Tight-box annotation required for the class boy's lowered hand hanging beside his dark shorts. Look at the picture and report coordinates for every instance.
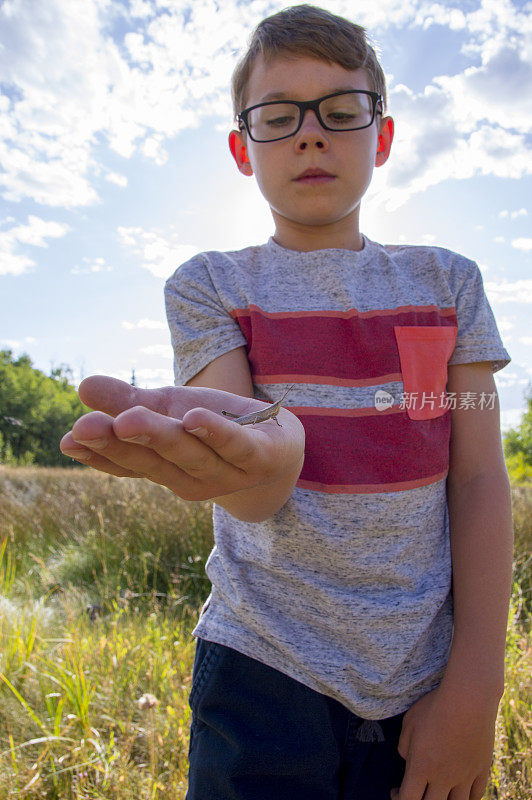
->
[391,683,498,800]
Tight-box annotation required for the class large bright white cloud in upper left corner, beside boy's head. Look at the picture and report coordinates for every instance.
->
[0,0,260,208]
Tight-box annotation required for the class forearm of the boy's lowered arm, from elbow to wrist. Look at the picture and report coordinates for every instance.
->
[444,472,513,695]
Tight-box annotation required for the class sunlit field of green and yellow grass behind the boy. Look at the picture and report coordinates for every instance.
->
[0,467,532,800]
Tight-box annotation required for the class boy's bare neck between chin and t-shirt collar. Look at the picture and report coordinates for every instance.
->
[271,207,364,252]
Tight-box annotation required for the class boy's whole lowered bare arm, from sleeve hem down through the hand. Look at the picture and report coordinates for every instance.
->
[392,362,513,800]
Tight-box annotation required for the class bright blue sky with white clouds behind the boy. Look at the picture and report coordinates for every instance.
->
[0,0,532,430]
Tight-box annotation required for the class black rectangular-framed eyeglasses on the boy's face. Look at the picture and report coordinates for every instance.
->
[236,89,382,142]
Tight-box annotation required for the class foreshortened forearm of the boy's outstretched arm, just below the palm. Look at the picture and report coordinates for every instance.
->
[213,455,305,522]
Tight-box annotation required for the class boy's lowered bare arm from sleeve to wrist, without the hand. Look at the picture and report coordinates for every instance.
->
[444,362,513,700]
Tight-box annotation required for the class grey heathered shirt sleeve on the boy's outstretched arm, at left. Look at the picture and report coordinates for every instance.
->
[164,253,246,386]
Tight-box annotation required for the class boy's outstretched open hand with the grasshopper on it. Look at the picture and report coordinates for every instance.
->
[59,375,305,500]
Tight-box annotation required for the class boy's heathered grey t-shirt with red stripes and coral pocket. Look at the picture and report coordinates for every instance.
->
[165,231,510,719]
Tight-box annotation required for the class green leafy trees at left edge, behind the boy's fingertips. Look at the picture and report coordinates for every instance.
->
[0,350,88,466]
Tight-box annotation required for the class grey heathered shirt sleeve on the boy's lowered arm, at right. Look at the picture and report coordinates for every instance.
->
[449,260,511,372]
